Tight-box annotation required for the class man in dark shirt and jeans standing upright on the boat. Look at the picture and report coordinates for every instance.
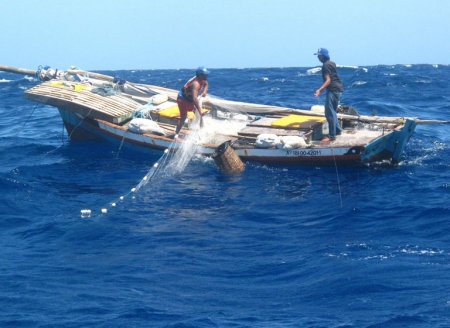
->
[314,48,344,142]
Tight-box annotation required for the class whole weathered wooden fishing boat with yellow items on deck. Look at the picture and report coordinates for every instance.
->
[0,67,432,165]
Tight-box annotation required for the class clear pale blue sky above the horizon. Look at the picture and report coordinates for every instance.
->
[0,0,450,70]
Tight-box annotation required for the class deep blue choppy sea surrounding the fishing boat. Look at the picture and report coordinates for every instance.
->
[0,65,450,328]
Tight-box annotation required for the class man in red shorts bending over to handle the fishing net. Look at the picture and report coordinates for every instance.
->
[175,67,209,134]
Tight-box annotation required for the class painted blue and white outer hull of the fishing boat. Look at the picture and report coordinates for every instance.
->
[59,108,415,165]
